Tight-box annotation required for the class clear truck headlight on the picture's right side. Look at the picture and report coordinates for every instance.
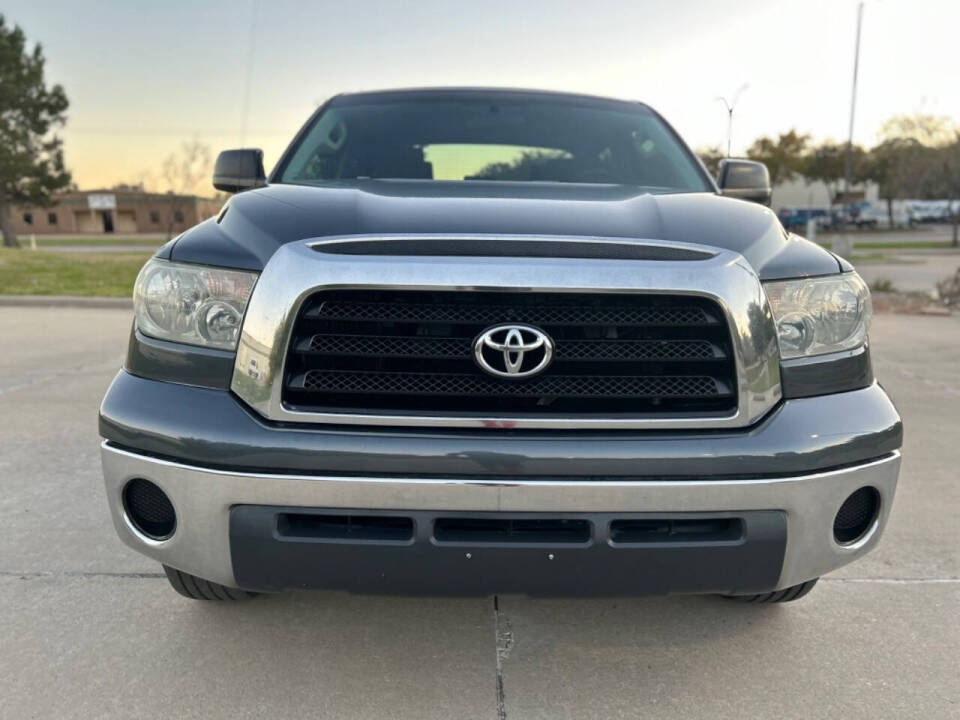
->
[764,273,873,359]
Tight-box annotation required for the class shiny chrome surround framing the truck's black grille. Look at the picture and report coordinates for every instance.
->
[231,234,781,429]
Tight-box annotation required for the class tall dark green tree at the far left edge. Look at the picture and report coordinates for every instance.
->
[0,15,70,247]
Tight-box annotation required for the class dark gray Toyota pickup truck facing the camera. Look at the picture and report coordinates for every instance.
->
[100,89,902,602]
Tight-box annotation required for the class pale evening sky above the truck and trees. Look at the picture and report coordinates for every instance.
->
[0,0,960,192]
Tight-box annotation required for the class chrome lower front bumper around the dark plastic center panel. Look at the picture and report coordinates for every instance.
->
[101,442,900,589]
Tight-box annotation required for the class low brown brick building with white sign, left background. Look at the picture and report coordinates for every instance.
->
[13,188,223,237]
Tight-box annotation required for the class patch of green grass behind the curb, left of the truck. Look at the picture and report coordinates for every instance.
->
[0,249,150,297]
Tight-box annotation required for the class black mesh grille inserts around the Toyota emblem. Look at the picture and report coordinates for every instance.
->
[283,290,737,419]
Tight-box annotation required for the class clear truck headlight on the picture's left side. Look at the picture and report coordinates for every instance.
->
[133,259,257,350]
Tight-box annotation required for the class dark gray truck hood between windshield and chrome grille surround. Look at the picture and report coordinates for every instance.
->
[167,180,841,280]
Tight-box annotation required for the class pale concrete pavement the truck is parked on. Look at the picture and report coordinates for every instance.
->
[0,307,960,720]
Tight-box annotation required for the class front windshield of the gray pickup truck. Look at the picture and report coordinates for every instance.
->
[279,98,711,192]
